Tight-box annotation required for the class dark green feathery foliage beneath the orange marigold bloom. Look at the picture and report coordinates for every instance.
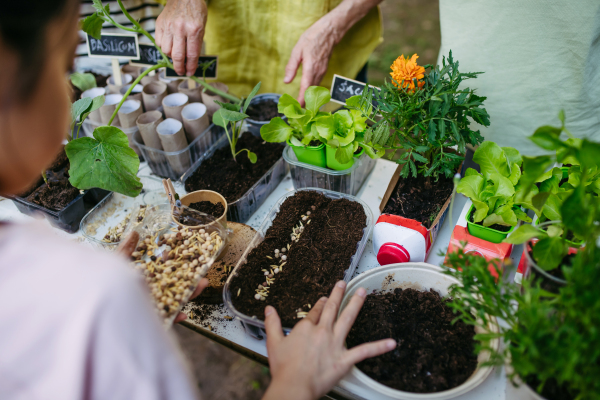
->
[349,52,490,180]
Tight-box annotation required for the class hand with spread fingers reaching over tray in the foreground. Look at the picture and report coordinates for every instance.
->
[263,281,396,400]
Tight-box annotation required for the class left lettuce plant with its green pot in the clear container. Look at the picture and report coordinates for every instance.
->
[260,86,331,167]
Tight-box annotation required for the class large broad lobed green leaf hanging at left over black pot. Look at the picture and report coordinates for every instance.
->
[65,126,142,197]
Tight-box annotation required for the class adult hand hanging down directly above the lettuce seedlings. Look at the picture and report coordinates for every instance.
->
[283,14,340,106]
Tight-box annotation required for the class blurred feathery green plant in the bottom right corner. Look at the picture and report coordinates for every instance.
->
[445,247,600,400]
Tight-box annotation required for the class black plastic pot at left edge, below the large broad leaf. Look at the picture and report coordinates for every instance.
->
[11,189,110,233]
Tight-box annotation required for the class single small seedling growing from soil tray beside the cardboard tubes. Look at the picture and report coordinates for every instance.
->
[213,82,260,164]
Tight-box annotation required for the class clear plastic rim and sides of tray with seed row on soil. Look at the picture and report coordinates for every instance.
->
[223,188,373,339]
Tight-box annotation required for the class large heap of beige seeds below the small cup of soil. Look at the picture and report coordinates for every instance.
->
[131,226,223,324]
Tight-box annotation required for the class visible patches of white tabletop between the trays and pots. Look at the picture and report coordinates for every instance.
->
[0,160,528,400]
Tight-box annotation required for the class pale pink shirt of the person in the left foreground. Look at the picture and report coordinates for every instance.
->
[0,222,198,400]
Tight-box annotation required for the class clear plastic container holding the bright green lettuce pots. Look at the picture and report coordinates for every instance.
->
[283,146,376,195]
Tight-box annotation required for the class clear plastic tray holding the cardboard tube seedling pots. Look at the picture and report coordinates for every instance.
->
[133,124,227,181]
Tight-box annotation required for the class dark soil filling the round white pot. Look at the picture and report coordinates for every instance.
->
[346,289,477,393]
